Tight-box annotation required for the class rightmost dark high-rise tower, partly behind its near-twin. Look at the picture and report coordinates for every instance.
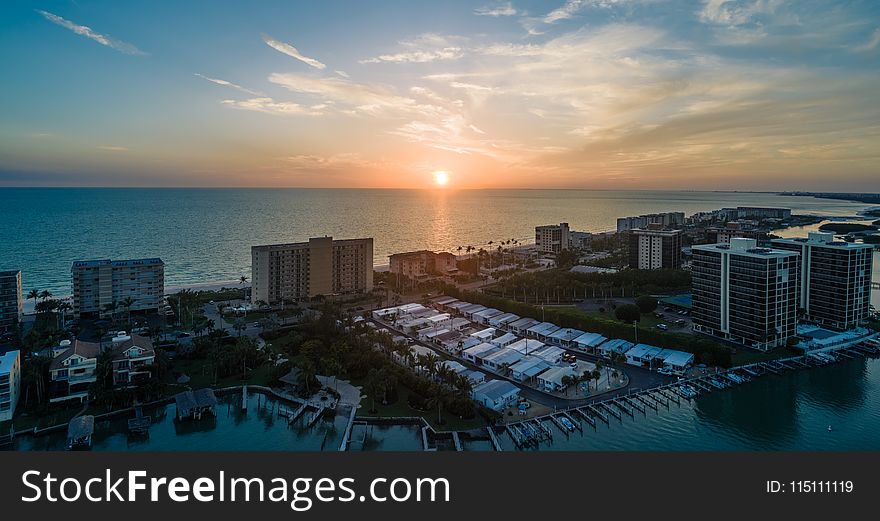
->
[771,232,874,330]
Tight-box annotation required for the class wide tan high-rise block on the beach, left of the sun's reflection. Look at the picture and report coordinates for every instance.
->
[251,237,373,304]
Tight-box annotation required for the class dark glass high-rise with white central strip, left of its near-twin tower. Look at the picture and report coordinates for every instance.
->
[692,238,800,351]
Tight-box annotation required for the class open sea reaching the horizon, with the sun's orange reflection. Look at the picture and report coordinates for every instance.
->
[0,188,865,295]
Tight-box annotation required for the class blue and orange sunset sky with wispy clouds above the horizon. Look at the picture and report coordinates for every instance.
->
[0,0,880,191]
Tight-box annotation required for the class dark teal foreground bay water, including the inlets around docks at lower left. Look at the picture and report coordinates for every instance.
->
[15,358,880,451]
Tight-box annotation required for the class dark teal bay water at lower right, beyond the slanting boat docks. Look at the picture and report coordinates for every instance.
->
[501,359,880,451]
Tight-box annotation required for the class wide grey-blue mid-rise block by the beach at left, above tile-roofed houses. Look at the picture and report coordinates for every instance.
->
[71,259,165,319]
